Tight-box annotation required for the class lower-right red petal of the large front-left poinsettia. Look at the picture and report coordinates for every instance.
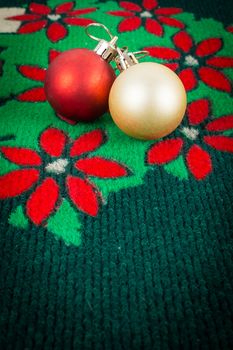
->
[66,176,99,216]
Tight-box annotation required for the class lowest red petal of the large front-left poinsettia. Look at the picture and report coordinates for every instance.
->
[26,178,59,225]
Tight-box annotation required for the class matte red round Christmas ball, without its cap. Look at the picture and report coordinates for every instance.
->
[45,49,116,121]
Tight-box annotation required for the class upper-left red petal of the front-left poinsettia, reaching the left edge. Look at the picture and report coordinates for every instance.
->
[0,146,42,166]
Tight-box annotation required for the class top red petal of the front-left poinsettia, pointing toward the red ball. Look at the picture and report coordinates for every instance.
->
[40,128,67,157]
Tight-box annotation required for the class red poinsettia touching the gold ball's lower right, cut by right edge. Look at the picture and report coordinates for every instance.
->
[147,98,233,180]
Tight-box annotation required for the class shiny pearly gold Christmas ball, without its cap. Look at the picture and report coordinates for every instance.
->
[109,62,187,140]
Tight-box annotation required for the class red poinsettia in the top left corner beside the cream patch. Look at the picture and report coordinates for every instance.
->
[7,1,96,42]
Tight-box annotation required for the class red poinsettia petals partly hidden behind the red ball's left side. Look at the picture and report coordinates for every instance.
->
[16,50,60,102]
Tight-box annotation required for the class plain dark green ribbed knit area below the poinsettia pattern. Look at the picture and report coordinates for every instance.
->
[0,154,233,350]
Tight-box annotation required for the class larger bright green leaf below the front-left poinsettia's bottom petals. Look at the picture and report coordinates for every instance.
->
[47,199,81,246]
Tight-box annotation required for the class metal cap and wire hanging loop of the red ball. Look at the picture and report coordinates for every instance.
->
[85,23,118,62]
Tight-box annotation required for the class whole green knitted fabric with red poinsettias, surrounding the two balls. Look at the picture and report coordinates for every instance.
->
[0,0,233,350]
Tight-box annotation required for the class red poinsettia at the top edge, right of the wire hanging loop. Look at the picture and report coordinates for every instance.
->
[108,0,184,36]
